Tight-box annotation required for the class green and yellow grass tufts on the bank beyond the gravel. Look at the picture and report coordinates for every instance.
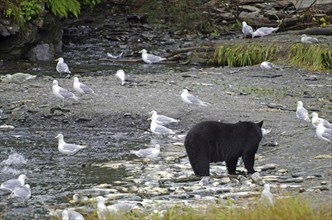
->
[204,41,332,71]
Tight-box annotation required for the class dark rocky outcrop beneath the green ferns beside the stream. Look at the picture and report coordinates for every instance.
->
[0,12,63,61]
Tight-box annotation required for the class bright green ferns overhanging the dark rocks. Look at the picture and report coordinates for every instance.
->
[0,0,102,26]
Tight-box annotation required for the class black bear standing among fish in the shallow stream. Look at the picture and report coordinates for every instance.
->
[184,121,263,176]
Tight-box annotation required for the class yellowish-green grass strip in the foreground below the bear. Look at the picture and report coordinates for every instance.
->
[79,198,332,220]
